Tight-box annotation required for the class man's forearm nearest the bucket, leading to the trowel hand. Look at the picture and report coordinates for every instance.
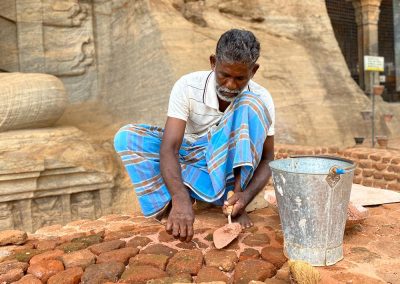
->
[239,160,271,204]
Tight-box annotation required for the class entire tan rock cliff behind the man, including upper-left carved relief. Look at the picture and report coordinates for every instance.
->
[0,0,400,145]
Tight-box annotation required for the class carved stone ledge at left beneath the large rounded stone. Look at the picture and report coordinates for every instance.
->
[0,127,118,233]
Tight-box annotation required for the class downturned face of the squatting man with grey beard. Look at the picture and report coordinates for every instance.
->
[210,55,259,102]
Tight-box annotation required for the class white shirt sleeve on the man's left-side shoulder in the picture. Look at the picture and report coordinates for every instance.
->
[167,78,189,121]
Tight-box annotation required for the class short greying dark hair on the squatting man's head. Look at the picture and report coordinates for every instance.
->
[215,29,260,65]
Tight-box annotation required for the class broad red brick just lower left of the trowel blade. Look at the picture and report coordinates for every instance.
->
[167,250,203,275]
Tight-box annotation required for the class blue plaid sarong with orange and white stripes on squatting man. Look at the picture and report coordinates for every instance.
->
[114,92,271,217]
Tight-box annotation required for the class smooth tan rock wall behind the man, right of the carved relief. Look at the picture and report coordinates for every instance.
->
[75,0,400,146]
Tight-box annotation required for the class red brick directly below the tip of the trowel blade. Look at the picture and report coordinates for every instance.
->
[204,249,238,272]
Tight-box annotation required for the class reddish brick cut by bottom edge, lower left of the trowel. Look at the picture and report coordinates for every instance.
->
[121,265,168,284]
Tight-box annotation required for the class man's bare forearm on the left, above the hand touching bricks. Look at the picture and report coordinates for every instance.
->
[160,151,190,200]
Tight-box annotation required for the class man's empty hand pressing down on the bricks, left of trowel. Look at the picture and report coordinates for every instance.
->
[165,197,194,242]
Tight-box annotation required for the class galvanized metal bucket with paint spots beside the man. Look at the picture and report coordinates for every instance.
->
[269,156,355,266]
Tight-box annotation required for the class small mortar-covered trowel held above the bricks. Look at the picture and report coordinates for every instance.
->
[213,191,242,249]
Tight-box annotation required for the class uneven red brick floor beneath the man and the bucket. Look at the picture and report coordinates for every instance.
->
[0,203,400,283]
